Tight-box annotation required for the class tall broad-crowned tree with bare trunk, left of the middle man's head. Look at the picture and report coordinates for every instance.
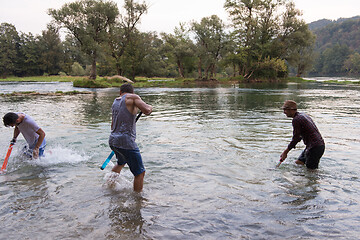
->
[48,0,119,79]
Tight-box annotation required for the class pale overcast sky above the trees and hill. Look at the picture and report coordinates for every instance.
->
[0,0,360,35]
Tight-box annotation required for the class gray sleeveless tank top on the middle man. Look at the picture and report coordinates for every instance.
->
[109,94,138,149]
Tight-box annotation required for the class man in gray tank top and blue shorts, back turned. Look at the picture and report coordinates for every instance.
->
[109,83,152,192]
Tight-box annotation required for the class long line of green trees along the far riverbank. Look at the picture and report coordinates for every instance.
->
[0,0,315,80]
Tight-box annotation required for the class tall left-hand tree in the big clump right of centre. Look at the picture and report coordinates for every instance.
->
[224,0,282,78]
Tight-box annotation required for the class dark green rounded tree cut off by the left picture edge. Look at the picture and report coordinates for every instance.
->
[0,23,19,77]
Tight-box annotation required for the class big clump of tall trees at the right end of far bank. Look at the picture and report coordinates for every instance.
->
[224,0,313,78]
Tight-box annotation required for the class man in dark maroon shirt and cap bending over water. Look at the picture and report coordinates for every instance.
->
[280,100,325,169]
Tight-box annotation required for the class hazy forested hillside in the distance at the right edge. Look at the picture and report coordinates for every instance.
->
[309,16,360,76]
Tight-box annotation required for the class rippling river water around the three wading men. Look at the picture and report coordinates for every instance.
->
[0,82,360,239]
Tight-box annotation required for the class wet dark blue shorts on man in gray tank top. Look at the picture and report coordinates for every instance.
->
[110,146,145,176]
